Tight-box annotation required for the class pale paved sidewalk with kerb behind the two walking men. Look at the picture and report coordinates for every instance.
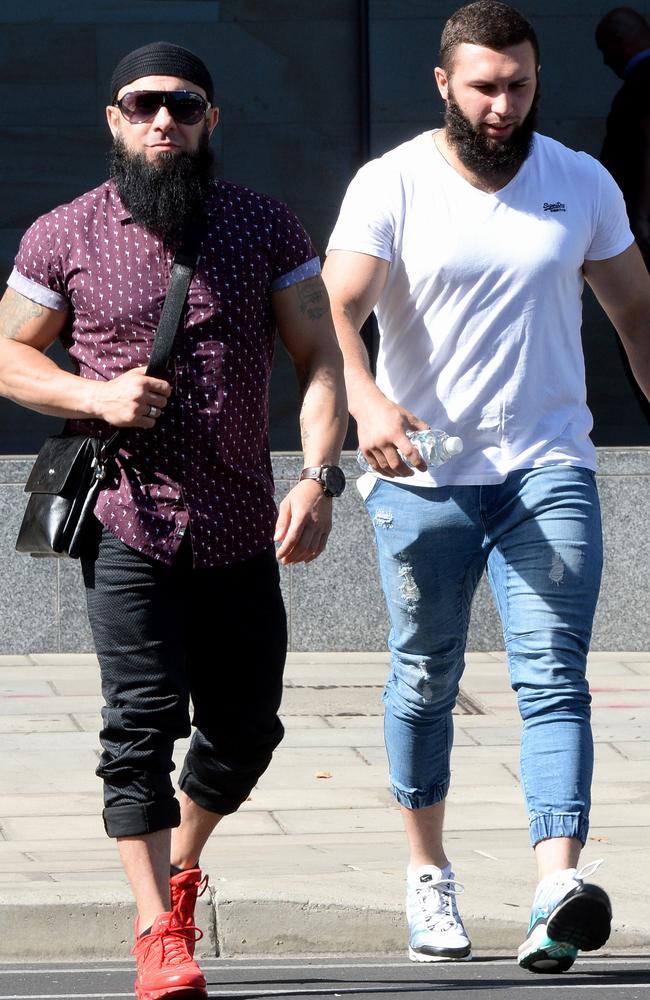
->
[0,652,650,960]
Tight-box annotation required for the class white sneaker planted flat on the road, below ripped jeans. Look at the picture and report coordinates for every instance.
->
[406,865,472,962]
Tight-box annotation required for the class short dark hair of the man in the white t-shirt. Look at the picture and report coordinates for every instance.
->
[440,0,539,73]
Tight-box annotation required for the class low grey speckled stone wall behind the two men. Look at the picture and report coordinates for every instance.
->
[0,448,650,653]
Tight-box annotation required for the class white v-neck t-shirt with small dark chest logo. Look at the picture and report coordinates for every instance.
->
[328,131,633,486]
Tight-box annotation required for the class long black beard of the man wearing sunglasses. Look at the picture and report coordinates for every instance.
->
[111,129,214,246]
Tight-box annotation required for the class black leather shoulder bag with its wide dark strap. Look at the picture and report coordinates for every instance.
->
[16,250,197,559]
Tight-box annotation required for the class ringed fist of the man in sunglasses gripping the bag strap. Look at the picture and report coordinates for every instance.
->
[88,367,172,430]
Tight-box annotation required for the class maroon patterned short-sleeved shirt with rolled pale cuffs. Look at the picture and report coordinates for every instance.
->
[8,181,320,566]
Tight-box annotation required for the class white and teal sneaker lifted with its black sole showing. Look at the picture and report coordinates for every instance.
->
[517,861,612,974]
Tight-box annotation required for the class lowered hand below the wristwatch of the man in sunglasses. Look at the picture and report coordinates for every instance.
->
[273,479,332,566]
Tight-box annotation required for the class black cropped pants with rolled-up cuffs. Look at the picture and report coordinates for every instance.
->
[82,530,287,837]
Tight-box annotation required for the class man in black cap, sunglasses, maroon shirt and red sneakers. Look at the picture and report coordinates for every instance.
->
[0,42,347,1000]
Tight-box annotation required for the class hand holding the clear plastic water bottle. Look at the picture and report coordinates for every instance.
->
[357,390,429,479]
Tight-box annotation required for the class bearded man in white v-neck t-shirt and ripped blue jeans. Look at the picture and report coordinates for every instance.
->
[324,0,650,972]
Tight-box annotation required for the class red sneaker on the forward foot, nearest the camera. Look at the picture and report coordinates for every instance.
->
[131,913,208,1000]
